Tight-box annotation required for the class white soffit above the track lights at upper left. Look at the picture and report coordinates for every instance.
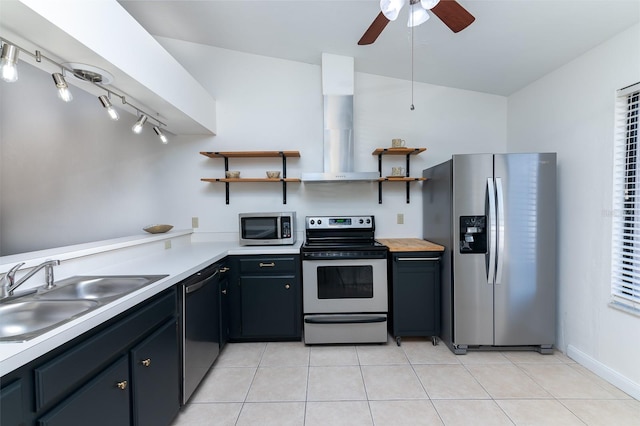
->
[0,0,216,135]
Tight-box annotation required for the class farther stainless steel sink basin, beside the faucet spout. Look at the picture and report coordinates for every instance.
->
[38,275,166,301]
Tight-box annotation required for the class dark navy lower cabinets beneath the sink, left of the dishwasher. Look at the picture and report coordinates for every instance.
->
[0,288,180,426]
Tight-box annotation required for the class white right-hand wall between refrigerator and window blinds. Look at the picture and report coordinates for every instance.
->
[508,25,640,398]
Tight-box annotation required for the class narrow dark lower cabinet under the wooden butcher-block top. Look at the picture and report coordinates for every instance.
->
[388,252,442,346]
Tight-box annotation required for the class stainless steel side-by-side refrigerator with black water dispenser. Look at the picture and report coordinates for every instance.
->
[422,153,557,354]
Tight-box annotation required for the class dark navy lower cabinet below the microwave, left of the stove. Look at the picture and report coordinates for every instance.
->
[229,255,302,341]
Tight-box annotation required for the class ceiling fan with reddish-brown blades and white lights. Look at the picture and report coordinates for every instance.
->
[358,0,476,45]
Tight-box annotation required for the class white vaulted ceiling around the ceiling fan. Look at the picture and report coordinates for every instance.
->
[119,0,640,95]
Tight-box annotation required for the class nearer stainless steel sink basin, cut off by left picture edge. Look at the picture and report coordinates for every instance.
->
[0,300,99,342]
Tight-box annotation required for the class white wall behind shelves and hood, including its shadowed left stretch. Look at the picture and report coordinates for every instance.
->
[0,39,507,254]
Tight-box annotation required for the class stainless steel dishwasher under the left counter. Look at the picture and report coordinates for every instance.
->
[179,263,228,404]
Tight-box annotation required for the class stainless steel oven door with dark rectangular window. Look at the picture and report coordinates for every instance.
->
[302,259,387,314]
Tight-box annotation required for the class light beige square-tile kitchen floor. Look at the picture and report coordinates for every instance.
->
[173,338,640,426]
